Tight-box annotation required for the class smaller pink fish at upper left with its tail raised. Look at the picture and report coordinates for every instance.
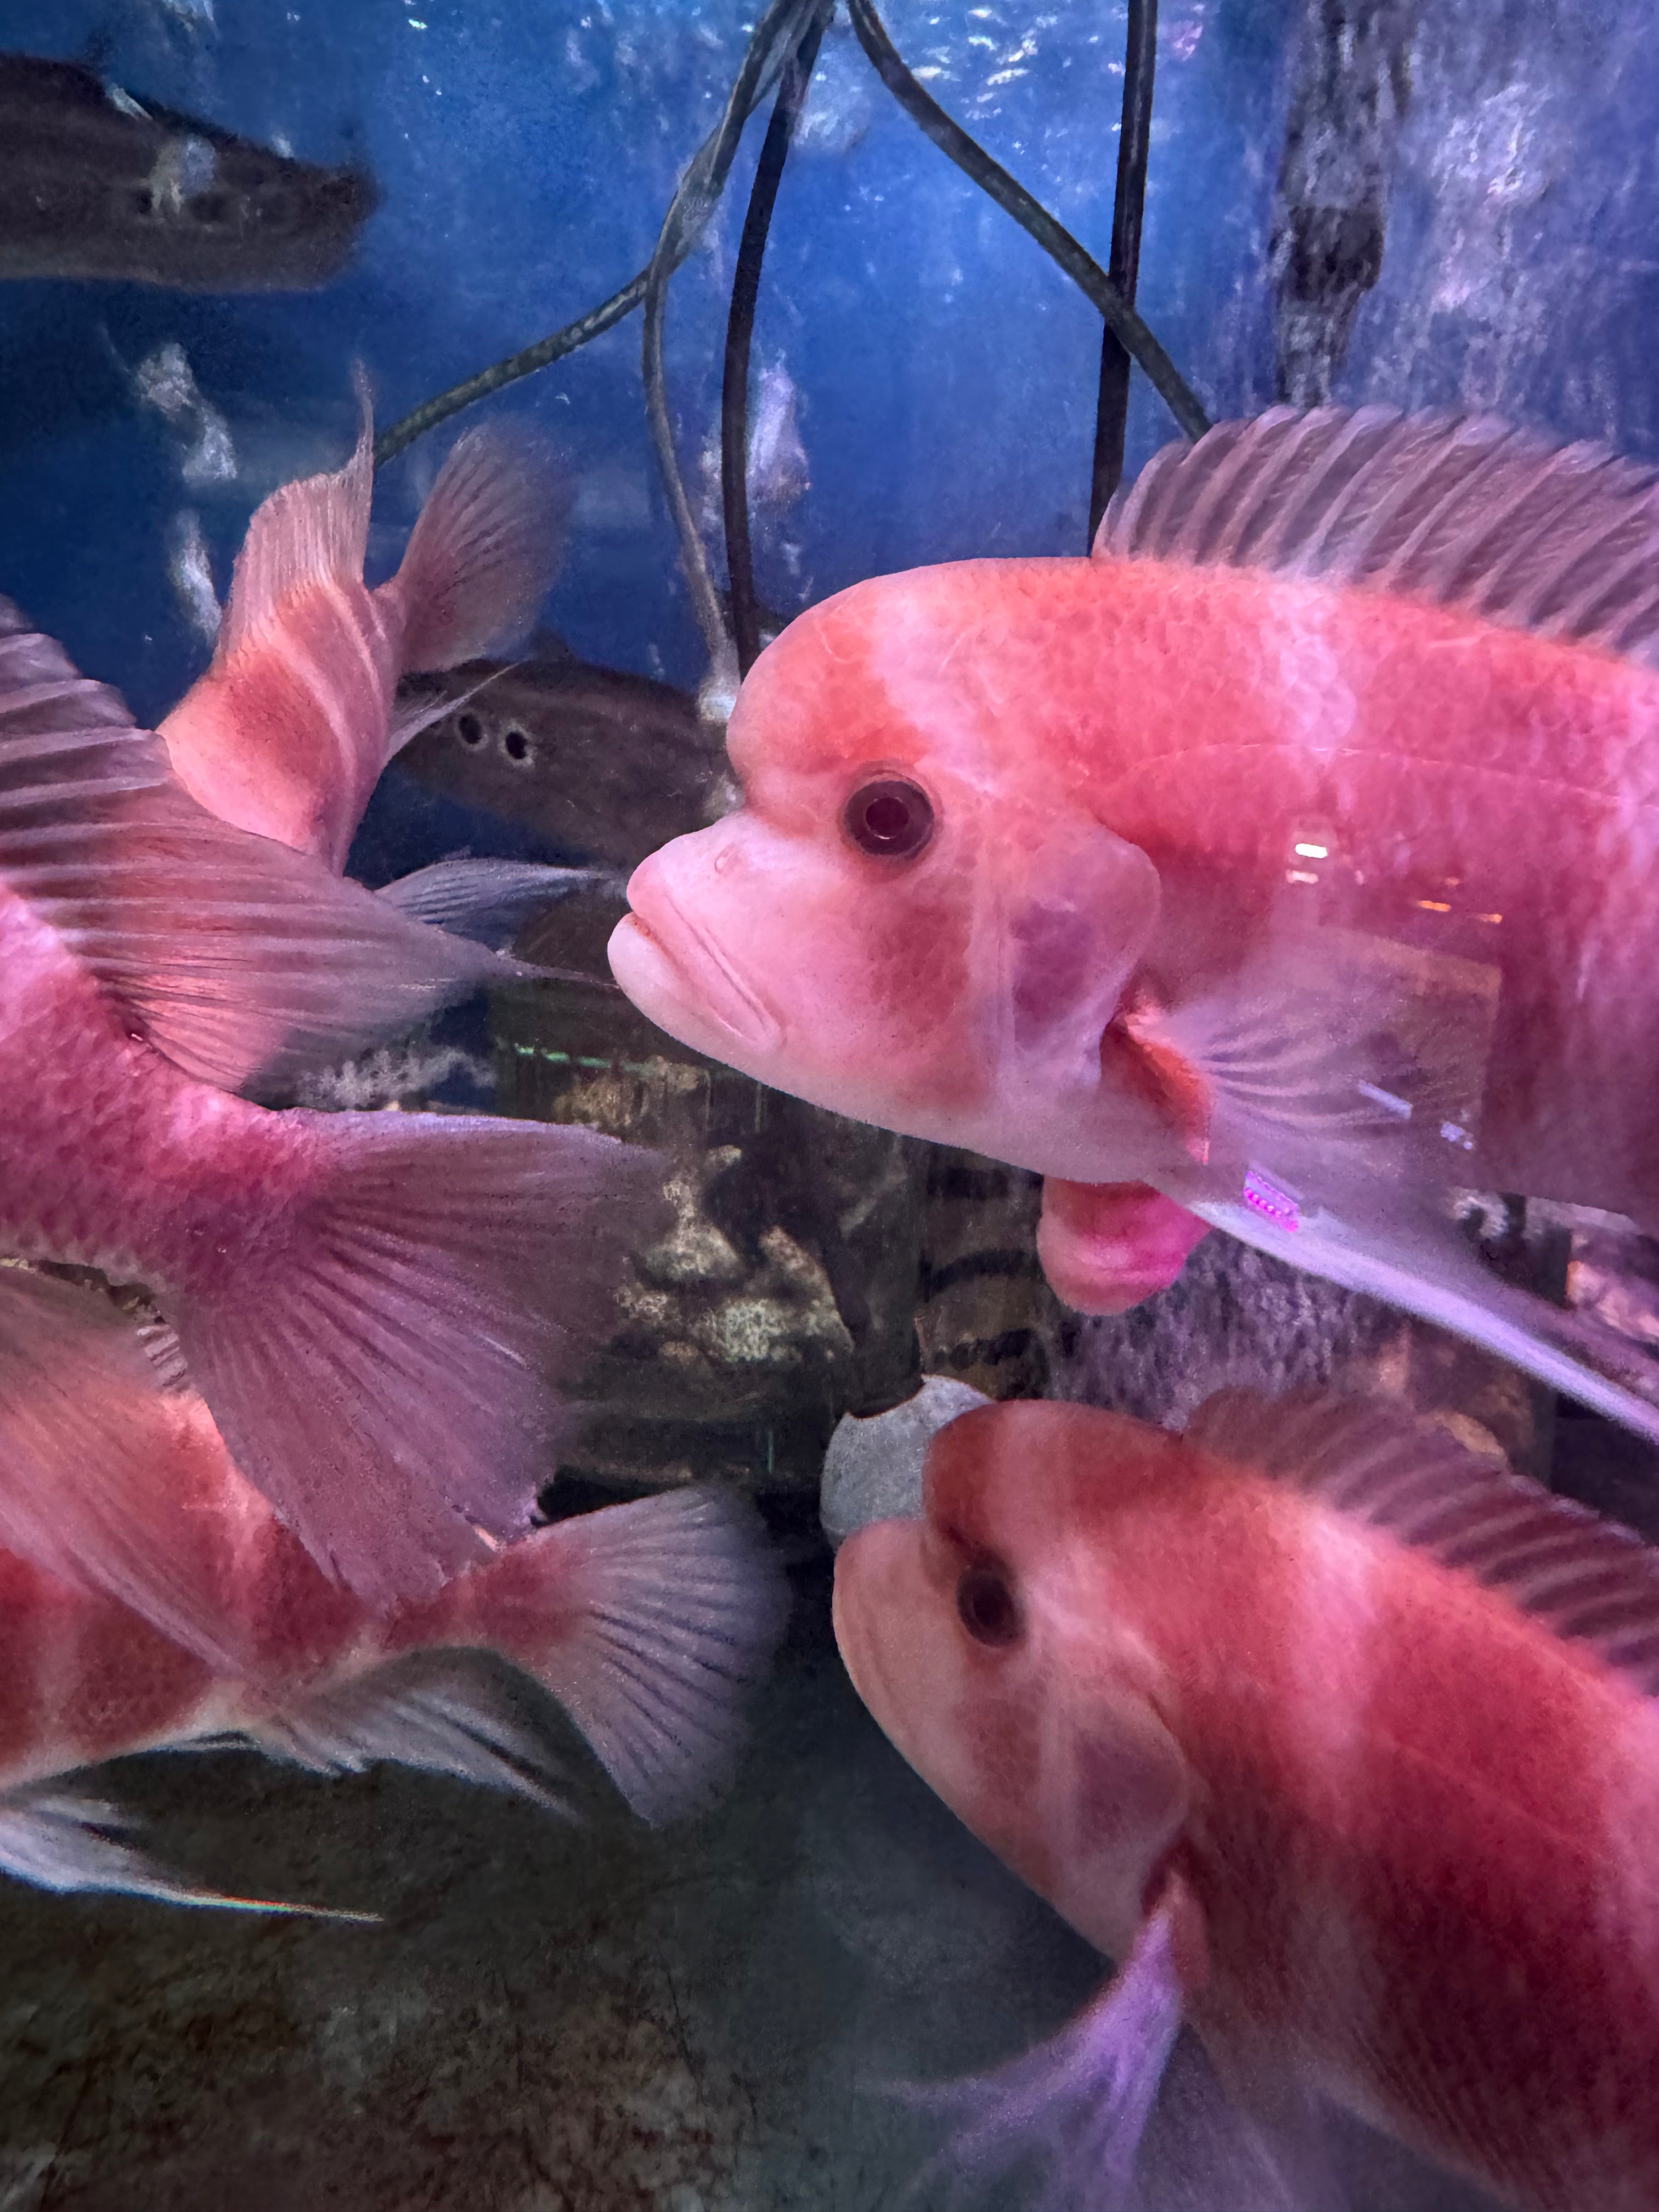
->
[161,403,568,874]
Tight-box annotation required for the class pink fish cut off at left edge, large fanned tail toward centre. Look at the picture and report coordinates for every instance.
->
[0,602,659,1657]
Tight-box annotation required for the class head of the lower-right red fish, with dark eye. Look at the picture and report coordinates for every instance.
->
[834,1400,1188,1955]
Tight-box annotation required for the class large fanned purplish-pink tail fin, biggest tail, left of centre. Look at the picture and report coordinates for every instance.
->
[168,1113,662,1606]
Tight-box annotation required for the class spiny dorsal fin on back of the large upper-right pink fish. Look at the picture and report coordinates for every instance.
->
[1095,407,1659,668]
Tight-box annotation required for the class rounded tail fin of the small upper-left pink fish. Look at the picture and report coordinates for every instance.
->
[387,425,571,676]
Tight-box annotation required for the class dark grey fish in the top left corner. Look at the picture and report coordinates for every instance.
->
[0,53,378,292]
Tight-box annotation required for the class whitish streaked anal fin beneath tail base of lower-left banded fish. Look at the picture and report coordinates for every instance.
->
[240,1650,579,1818]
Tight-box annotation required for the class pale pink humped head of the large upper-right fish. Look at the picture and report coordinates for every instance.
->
[611,579,1161,1179]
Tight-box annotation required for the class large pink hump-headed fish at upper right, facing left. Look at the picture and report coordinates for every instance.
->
[611,409,1659,1434]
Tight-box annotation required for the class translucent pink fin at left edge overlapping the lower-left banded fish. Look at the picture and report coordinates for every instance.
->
[0,1267,246,1674]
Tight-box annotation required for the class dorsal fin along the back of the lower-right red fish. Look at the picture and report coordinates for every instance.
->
[1186,1389,1659,1695]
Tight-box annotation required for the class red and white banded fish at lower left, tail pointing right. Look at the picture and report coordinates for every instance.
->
[0,1269,783,1903]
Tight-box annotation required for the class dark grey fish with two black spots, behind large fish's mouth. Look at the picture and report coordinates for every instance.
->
[396,633,725,867]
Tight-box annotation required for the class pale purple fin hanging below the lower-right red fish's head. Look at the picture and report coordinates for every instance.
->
[896,1882,1197,2212]
